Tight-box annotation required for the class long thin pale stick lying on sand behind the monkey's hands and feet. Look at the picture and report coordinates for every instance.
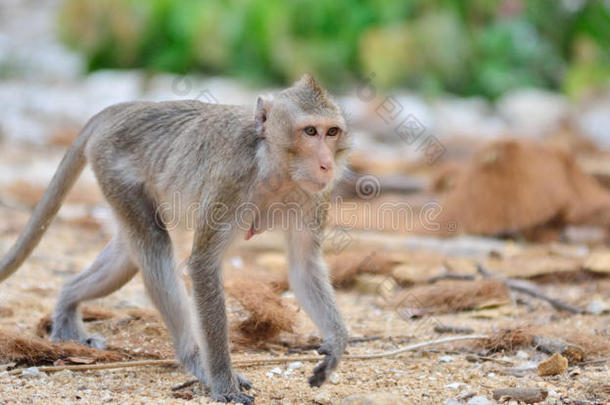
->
[3,335,489,375]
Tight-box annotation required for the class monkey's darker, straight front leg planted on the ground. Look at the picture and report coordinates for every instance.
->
[189,229,254,404]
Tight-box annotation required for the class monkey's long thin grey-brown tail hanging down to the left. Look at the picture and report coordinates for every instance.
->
[0,119,95,282]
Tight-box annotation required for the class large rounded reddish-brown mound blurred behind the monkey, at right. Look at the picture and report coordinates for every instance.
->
[430,140,610,235]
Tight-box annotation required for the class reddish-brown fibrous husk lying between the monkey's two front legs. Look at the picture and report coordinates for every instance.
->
[226,277,295,344]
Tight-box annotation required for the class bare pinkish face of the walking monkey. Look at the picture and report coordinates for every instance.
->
[289,116,346,192]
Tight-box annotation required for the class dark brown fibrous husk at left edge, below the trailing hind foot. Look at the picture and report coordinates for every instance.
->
[0,331,125,366]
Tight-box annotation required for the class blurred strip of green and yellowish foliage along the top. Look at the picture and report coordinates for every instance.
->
[59,0,610,98]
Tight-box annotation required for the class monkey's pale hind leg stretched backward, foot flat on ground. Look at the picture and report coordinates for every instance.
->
[51,235,138,349]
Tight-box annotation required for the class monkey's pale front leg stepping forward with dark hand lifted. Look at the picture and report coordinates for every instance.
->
[288,228,348,387]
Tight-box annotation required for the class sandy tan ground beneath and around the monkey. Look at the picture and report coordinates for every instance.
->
[0,146,610,404]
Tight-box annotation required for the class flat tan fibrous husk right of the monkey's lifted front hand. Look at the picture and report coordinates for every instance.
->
[390,280,510,313]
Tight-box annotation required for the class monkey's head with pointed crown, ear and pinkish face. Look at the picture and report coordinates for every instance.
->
[255,74,350,192]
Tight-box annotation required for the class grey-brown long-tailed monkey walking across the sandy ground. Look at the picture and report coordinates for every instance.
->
[0,74,351,404]
